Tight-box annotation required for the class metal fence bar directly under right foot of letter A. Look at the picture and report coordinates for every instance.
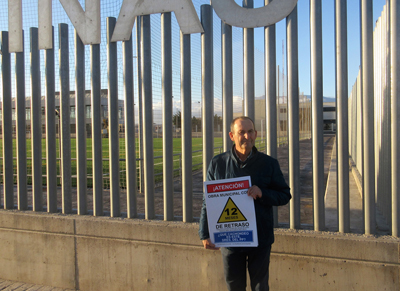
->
[181,32,193,222]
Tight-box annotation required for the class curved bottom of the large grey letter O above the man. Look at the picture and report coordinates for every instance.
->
[211,0,297,28]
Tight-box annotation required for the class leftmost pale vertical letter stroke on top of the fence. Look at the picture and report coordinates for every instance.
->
[8,0,23,53]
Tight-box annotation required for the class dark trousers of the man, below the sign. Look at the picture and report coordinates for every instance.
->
[221,246,271,291]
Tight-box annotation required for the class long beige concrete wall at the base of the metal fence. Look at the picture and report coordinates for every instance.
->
[0,210,400,291]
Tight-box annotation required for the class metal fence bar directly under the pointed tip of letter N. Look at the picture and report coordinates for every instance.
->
[90,44,103,216]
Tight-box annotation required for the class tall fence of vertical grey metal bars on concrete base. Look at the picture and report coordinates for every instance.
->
[0,0,399,236]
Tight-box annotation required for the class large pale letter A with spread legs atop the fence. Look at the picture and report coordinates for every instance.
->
[111,0,203,41]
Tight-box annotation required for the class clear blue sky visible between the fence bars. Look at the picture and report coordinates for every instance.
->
[0,0,386,104]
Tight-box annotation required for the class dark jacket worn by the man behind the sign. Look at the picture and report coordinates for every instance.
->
[199,146,292,247]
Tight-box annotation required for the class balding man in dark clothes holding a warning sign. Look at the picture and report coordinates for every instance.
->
[199,116,291,291]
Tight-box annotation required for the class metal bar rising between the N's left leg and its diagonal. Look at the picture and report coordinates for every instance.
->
[58,23,72,213]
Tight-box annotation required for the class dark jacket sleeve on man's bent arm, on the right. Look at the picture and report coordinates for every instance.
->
[260,159,292,206]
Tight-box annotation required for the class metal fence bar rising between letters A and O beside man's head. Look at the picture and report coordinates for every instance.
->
[201,4,214,179]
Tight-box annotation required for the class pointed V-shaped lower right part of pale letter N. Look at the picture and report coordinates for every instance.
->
[60,0,101,44]
